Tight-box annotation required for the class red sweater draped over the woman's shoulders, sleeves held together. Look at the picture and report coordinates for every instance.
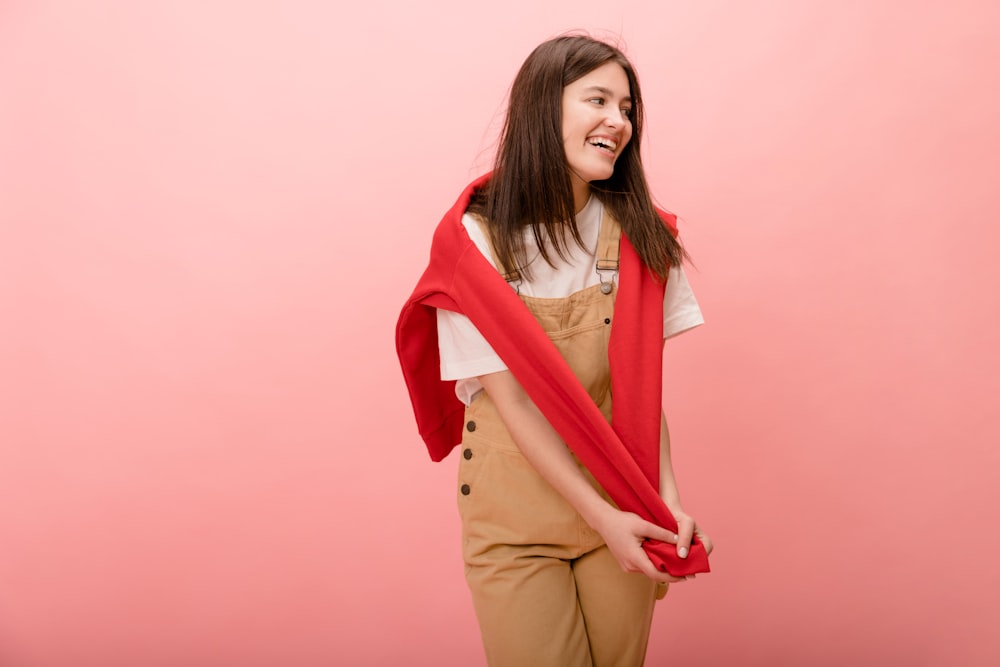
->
[396,175,709,576]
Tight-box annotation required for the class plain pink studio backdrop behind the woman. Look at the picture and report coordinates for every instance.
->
[0,0,1000,667]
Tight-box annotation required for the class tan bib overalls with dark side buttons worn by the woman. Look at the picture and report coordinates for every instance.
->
[458,214,665,667]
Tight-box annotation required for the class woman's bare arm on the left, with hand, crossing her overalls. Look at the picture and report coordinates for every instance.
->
[479,371,691,582]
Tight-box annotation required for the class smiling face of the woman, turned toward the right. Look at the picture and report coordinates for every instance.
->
[562,62,632,211]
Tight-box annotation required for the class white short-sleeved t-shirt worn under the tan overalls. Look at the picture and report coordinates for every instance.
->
[437,196,705,405]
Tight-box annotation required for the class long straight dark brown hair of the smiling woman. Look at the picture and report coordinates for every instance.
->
[469,35,686,279]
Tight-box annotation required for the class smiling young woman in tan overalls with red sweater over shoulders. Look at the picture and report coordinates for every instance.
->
[397,36,712,667]
